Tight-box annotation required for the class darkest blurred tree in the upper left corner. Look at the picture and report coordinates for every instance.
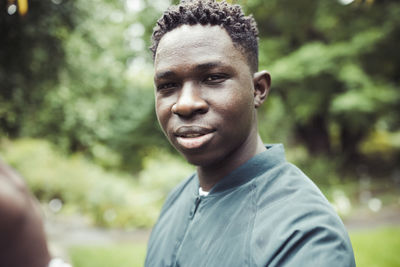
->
[0,0,77,137]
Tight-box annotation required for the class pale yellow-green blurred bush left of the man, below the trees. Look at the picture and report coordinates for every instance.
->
[0,139,191,227]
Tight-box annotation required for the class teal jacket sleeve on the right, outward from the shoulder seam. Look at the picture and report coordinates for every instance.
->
[253,162,354,266]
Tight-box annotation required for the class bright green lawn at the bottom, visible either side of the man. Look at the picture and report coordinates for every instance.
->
[70,226,400,267]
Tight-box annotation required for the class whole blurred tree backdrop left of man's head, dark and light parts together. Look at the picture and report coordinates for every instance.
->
[0,0,170,171]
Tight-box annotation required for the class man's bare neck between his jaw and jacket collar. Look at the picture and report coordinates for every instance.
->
[197,134,266,192]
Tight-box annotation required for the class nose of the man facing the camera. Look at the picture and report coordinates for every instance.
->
[171,83,208,117]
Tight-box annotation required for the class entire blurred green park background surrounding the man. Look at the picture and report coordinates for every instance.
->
[0,0,400,267]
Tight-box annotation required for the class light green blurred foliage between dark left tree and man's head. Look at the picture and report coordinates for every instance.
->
[27,1,165,171]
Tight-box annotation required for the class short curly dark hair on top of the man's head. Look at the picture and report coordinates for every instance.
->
[150,0,258,72]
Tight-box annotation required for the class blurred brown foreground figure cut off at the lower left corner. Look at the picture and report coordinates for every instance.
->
[0,160,50,267]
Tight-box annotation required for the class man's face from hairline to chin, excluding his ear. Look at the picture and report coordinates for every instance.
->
[154,25,257,166]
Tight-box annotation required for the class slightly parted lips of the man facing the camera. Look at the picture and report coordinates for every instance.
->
[174,126,215,149]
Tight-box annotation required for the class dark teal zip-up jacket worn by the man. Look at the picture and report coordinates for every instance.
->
[145,145,355,267]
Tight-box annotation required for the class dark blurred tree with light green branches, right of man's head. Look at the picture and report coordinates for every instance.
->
[246,0,400,172]
